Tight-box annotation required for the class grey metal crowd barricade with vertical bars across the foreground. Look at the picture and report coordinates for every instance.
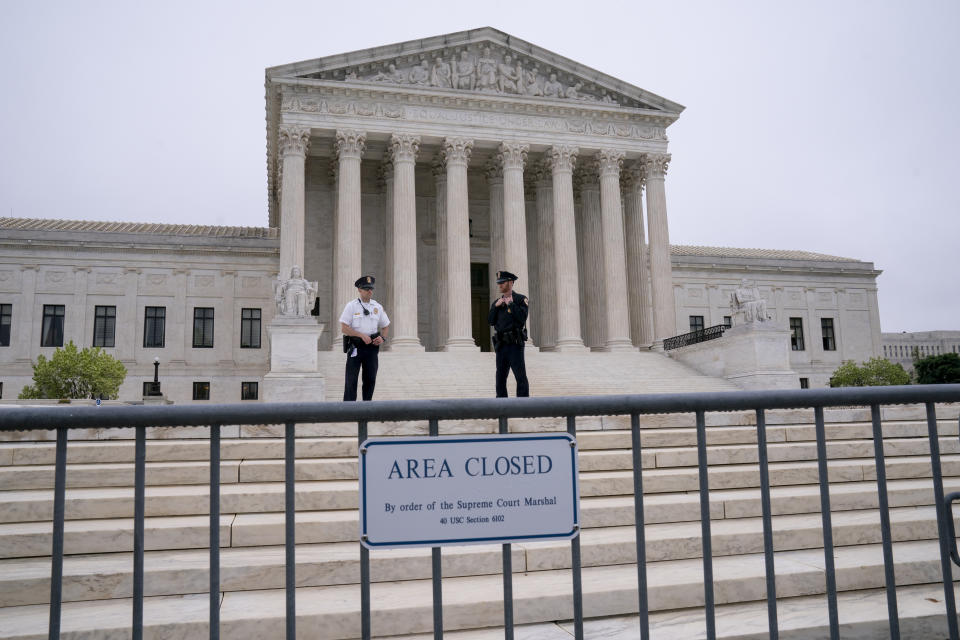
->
[0,385,960,640]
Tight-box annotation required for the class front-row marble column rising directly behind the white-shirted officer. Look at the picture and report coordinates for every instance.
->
[330,130,366,350]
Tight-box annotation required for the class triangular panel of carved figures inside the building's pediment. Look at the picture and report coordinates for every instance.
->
[309,44,655,109]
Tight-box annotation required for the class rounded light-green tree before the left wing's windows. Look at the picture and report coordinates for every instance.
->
[19,341,127,400]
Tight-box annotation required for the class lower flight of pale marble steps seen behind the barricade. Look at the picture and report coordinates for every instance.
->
[0,398,960,640]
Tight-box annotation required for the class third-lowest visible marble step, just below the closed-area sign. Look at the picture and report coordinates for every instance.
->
[0,506,960,606]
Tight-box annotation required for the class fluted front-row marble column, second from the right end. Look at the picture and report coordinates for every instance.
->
[597,149,633,351]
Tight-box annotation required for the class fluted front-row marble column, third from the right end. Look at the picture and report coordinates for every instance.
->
[547,145,584,351]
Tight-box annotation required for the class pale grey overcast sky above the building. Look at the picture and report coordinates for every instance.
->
[0,0,960,331]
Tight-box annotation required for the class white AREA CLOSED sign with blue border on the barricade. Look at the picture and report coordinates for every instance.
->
[360,434,580,548]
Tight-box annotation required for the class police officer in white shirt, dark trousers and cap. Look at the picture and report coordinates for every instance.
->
[340,276,390,401]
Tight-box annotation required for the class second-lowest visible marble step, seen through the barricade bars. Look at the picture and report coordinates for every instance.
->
[0,541,940,640]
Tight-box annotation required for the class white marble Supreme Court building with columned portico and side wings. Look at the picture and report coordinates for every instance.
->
[0,28,880,402]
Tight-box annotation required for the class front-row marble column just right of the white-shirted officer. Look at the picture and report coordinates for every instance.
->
[387,134,423,351]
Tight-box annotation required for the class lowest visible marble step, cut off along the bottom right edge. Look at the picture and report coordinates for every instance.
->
[382,584,960,640]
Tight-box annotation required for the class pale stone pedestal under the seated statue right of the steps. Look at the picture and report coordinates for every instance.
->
[669,322,800,390]
